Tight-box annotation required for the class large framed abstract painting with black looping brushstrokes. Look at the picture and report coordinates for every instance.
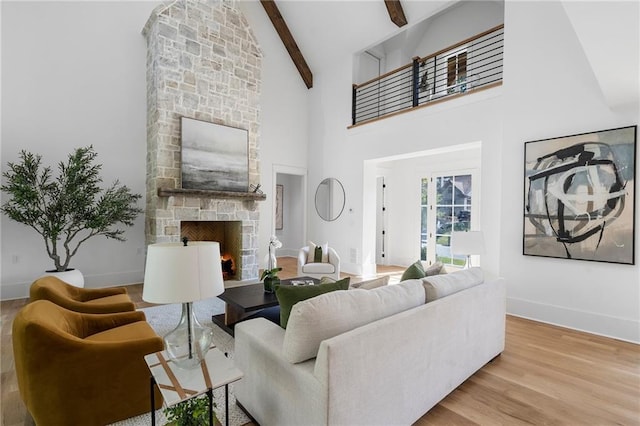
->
[523,126,637,265]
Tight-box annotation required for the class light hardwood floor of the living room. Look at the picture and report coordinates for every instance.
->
[0,258,640,426]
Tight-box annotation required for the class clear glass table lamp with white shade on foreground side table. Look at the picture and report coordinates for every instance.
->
[142,238,224,368]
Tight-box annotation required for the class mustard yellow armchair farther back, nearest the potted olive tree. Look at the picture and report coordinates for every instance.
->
[29,276,136,314]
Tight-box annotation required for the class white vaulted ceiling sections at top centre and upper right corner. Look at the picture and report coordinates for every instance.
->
[254,0,640,109]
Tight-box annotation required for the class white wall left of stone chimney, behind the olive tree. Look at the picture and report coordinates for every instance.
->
[0,2,156,299]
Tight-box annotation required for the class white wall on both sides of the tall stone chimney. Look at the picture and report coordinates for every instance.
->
[0,1,308,299]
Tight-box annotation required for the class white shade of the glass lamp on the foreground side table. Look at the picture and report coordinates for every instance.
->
[142,241,224,303]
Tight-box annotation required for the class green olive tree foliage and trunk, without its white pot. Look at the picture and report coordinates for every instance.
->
[0,146,142,286]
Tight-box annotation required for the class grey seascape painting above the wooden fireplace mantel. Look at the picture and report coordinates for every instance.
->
[181,117,249,192]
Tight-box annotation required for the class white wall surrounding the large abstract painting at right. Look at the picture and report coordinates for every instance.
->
[500,2,640,342]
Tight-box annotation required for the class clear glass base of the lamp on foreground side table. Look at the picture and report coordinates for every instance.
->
[164,302,213,368]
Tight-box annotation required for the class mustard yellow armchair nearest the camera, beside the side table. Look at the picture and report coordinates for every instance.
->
[13,300,163,426]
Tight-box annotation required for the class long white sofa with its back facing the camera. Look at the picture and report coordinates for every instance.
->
[234,268,506,426]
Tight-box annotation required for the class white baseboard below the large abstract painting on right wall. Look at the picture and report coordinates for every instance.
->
[507,297,640,344]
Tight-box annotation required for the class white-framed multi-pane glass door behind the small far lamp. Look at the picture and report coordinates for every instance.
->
[420,172,477,266]
